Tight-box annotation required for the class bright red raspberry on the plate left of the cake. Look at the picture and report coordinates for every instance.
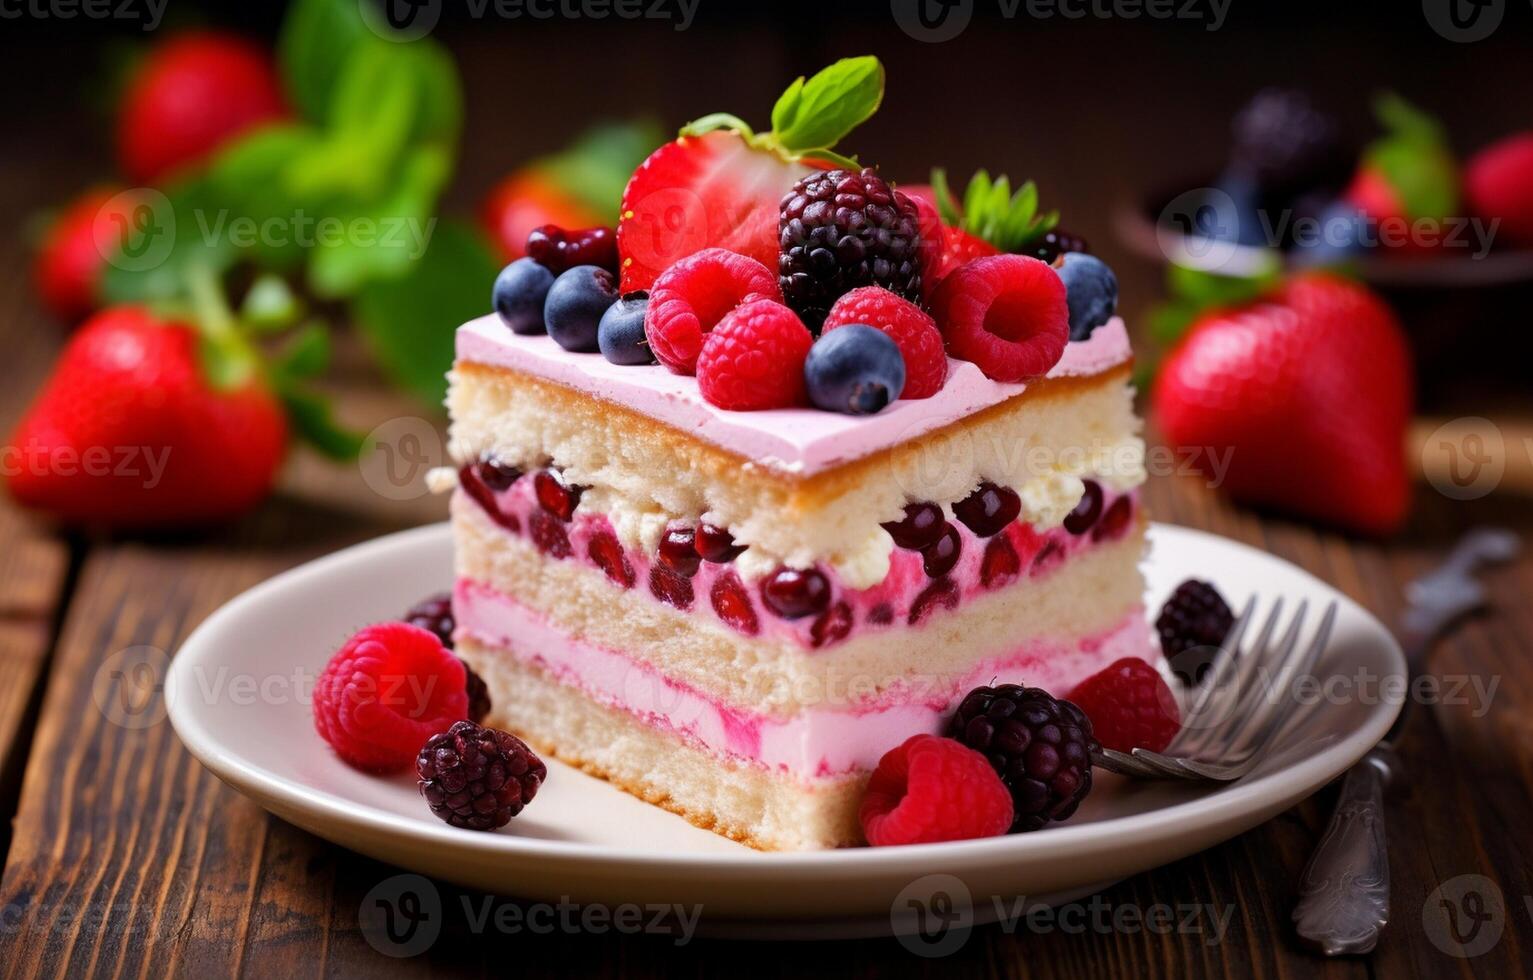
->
[314,623,469,773]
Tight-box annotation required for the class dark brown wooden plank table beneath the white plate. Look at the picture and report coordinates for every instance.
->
[0,9,1533,977]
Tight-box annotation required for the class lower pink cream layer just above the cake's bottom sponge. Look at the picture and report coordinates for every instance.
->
[454,580,1153,782]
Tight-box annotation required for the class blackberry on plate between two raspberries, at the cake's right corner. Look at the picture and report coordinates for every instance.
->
[947,684,1096,833]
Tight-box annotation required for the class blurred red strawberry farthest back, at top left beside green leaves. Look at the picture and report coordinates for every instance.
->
[117,31,288,184]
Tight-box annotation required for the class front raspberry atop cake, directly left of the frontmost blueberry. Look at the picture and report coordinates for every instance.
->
[698,299,814,411]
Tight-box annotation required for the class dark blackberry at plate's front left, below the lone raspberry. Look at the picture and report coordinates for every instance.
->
[415,721,549,830]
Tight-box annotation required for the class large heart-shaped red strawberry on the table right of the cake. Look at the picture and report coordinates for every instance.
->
[1153,273,1412,534]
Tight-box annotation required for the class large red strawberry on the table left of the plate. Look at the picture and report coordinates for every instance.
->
[8,307,288,528]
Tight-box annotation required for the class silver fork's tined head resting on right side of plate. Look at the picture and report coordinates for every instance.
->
[1091,597,1337,782]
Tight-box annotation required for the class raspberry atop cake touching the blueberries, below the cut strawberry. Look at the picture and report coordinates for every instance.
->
[644,248,782,374]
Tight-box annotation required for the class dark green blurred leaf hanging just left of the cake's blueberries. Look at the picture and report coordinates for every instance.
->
[351,221,498,405]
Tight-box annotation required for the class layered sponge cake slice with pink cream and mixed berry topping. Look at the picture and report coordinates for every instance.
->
[449,58,1153,850]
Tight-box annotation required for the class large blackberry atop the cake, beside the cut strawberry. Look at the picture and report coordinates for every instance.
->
[777,169,921,333]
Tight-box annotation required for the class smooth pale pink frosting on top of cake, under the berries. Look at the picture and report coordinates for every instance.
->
[457,314,1130,475]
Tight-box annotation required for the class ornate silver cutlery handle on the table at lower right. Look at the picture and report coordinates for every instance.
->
[1294,750,1389,955]
